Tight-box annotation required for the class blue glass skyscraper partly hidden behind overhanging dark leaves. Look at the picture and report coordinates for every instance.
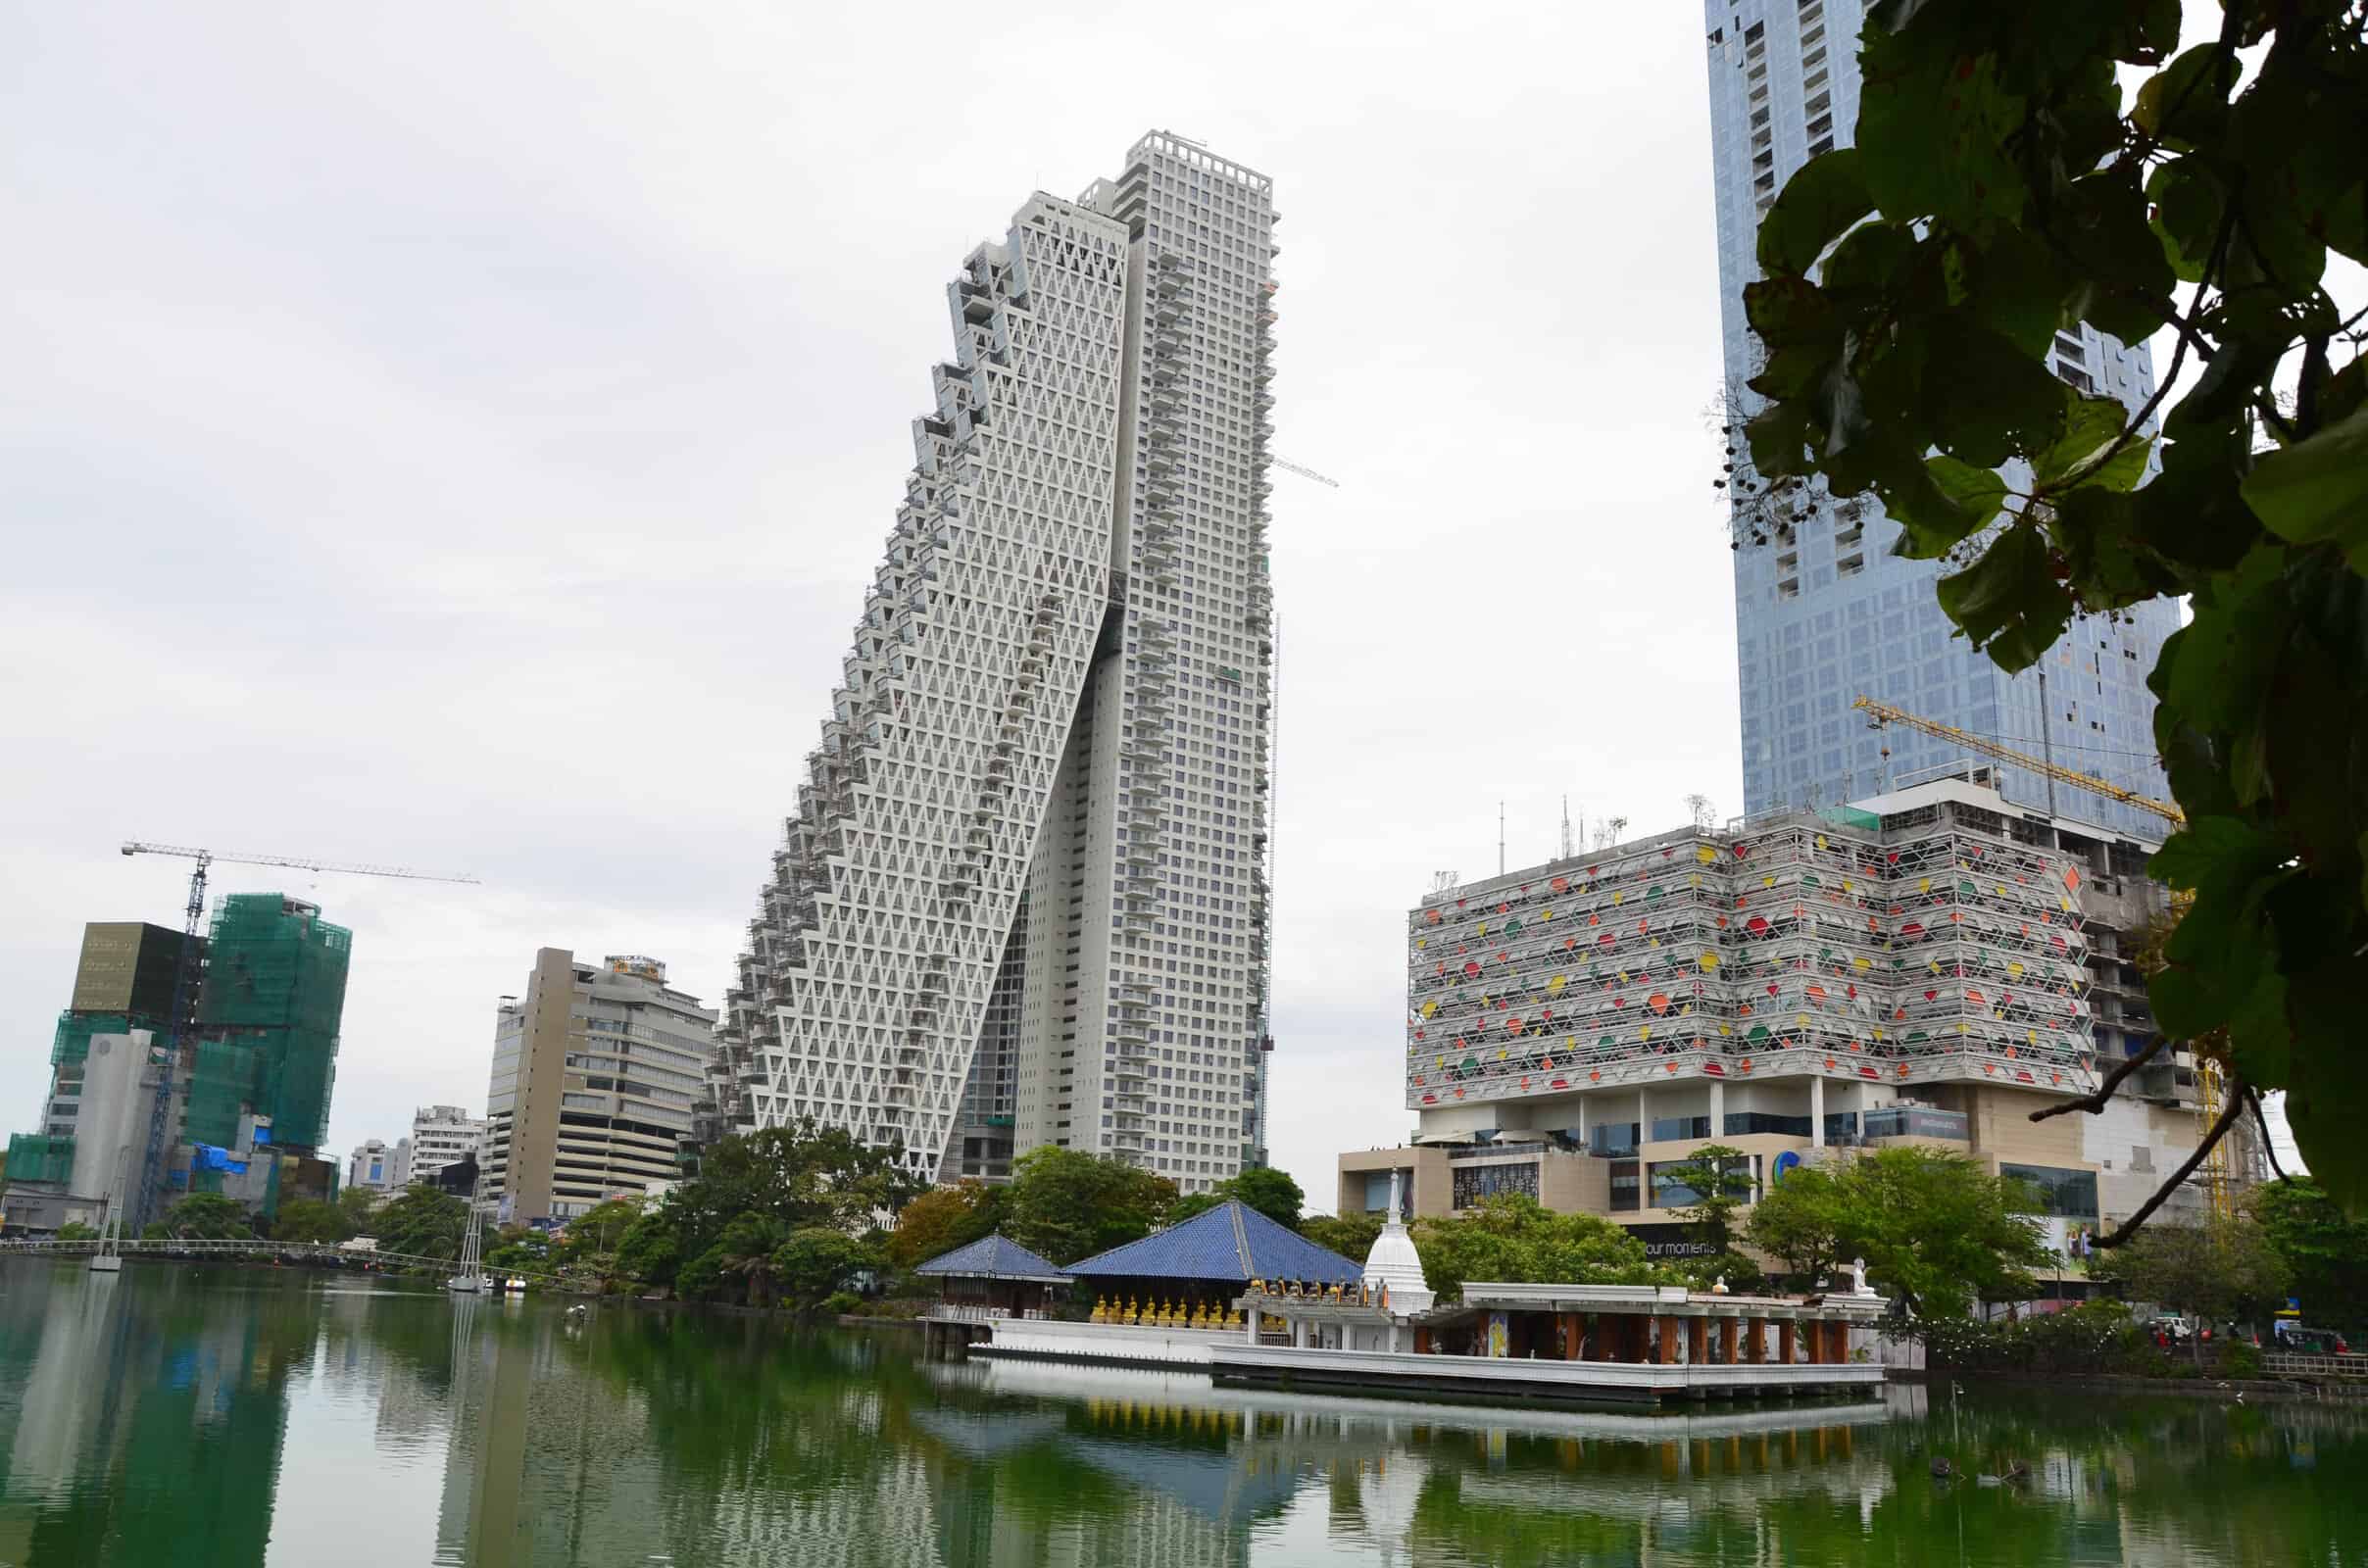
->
[1702,0,2179,839]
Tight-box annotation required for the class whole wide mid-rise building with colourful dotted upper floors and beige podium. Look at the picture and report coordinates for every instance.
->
[1338,767,2202,1249]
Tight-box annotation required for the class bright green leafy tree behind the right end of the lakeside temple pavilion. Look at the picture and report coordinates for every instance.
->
[1746,1144,2053,1317]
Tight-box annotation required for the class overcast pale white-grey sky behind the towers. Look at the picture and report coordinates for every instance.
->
[14,0,2273,1208]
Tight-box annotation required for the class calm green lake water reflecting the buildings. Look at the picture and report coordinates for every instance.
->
[0,1260,2368,1568]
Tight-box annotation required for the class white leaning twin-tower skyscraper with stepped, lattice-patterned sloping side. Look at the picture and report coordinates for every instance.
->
[719,132,1276,1192]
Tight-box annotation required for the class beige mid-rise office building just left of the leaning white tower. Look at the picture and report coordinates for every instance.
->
[483,948,715,1220]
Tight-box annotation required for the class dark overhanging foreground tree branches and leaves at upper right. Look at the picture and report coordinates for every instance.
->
[1736,0,2368,1212]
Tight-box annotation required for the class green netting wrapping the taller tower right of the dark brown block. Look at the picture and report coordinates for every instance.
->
[197,893,353,1149]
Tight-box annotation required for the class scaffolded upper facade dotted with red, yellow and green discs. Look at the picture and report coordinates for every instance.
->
[1406,810,2096,1106]
